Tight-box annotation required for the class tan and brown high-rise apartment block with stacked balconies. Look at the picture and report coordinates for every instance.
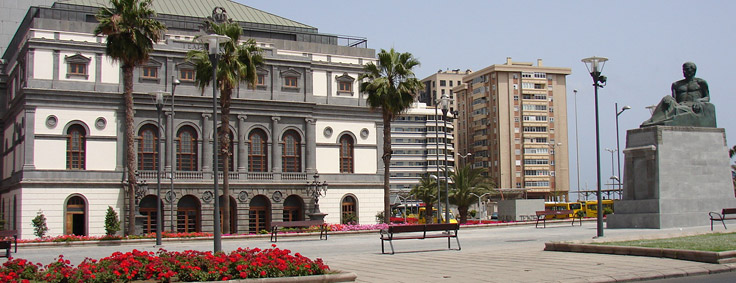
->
[454,58,571,200]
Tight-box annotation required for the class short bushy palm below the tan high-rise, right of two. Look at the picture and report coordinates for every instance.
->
[450,165,495,223]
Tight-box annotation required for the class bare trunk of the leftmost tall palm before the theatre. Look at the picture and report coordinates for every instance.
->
[122,64,138,235]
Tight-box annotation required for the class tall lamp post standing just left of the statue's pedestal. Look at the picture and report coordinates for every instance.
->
[581,57,608,237]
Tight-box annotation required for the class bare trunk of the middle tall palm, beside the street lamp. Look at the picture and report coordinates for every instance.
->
[220,89,233,234]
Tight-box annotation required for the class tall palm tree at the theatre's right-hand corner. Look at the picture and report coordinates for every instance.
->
[358,48,422,223]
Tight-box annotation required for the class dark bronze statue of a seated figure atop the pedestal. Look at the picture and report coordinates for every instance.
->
[641,62,716,128]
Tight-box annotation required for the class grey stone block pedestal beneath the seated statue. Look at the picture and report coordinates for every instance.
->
[606,126,736,229]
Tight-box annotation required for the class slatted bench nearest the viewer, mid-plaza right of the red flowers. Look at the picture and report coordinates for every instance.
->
[380,223,461,254]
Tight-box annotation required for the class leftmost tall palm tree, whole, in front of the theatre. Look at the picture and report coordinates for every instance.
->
[95,0,166,235]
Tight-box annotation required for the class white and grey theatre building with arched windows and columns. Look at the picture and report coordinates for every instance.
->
[0,0,383,238]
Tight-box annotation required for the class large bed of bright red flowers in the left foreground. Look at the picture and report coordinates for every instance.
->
[0,245,329,282]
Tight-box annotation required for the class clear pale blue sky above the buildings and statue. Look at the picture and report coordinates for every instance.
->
[235,0,736,198]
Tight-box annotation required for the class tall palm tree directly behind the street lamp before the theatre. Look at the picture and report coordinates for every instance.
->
[187,21,264,234]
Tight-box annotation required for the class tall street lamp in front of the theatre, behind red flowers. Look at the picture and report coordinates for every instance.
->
[200,34,230,252]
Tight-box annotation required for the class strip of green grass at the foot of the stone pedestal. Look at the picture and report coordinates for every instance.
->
[596,233,736,252]
